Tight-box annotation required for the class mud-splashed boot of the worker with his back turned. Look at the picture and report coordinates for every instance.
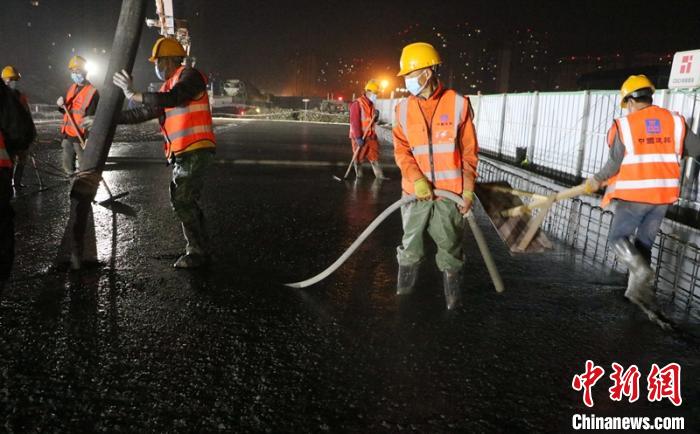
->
[614,239,657,310]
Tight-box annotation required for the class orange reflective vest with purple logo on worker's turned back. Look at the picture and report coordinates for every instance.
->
[601,106,686,206]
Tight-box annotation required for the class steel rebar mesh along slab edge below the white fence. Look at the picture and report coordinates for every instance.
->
[479,159,700,317]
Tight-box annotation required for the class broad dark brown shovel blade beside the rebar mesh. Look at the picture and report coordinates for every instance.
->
[476,181,553,254]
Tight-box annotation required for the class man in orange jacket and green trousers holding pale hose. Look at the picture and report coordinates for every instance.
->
[393,42,478,309]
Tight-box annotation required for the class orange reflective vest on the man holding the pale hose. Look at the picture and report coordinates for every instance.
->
[396,89,469,195]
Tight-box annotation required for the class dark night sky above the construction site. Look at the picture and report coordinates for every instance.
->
[0,0,700,100]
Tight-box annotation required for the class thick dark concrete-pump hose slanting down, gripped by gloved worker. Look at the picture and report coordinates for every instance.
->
[59,0,147,268]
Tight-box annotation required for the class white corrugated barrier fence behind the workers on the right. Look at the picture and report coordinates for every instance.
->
[377,89,700,179]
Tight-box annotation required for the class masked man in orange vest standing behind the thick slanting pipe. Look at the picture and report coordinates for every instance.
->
[56,56,100,175]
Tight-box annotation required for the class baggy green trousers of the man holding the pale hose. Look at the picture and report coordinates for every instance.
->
[396,200,464,271]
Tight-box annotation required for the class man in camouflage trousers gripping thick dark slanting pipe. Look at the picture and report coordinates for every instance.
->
[87,38,216,268]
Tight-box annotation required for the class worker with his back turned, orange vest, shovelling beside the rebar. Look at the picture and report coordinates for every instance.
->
[585,75,700,311]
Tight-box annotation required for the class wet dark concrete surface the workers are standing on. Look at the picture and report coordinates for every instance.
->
[0,121,700,432]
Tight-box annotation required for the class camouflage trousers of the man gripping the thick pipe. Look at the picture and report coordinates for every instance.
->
[170,149,214,255]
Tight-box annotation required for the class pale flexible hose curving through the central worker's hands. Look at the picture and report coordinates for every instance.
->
[285,190,505,292]
